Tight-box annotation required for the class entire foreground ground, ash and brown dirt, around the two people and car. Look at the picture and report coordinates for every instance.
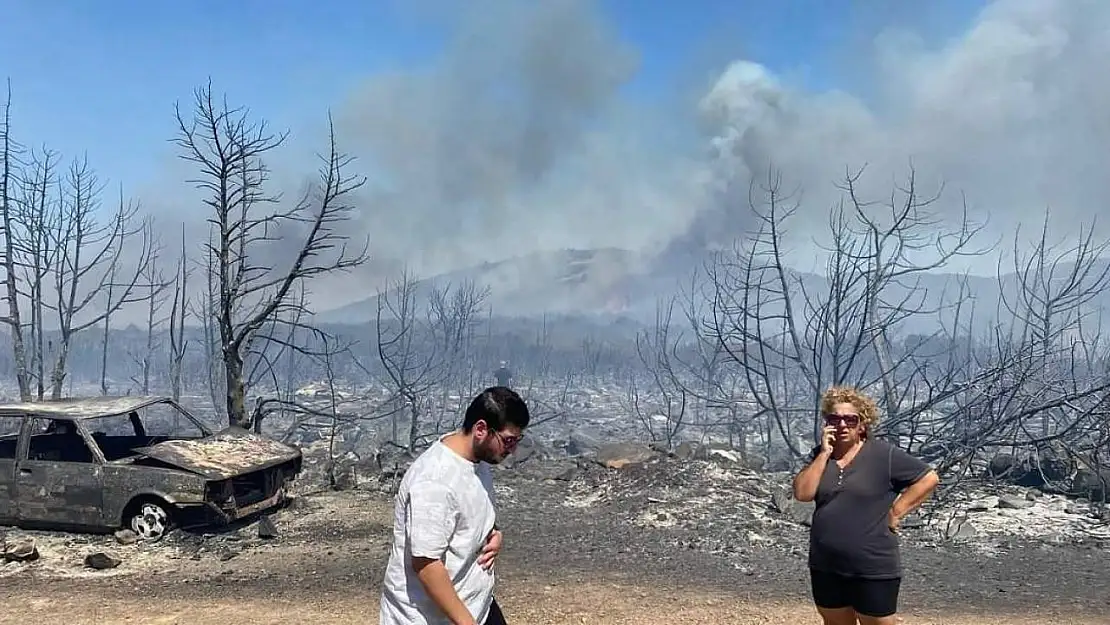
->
[0,448,1110,625]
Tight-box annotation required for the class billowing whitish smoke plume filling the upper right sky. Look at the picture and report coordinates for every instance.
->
[702,0,1110,272]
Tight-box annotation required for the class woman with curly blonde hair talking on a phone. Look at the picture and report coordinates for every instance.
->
[794,386,939,625]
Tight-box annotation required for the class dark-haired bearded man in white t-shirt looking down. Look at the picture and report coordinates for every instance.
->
[380,386,529,625]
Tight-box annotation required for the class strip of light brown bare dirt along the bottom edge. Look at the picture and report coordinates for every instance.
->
[0,581,1110,625]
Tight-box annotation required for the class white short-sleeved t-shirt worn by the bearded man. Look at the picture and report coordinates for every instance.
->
[380,437,496,625]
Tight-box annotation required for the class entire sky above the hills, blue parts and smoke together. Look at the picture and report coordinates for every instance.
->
[0,0,1110,310]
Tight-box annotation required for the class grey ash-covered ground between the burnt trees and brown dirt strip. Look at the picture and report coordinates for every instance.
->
[0,445,1110,623]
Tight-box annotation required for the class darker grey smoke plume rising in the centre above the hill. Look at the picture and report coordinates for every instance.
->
[330,0,698,286]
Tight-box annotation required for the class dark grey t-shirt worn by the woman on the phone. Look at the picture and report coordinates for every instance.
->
[809,440,931,579]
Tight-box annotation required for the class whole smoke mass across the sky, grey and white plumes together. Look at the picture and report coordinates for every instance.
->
[110,0,1110,309]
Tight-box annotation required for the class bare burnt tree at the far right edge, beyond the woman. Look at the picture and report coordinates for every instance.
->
[923,213,1110,485]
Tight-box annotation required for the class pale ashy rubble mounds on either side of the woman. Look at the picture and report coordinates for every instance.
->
[541,446,1110,552]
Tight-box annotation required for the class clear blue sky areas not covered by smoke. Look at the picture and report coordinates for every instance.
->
[0,0,981,194]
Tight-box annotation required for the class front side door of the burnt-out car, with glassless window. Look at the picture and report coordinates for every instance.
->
[16,417,103,527]
